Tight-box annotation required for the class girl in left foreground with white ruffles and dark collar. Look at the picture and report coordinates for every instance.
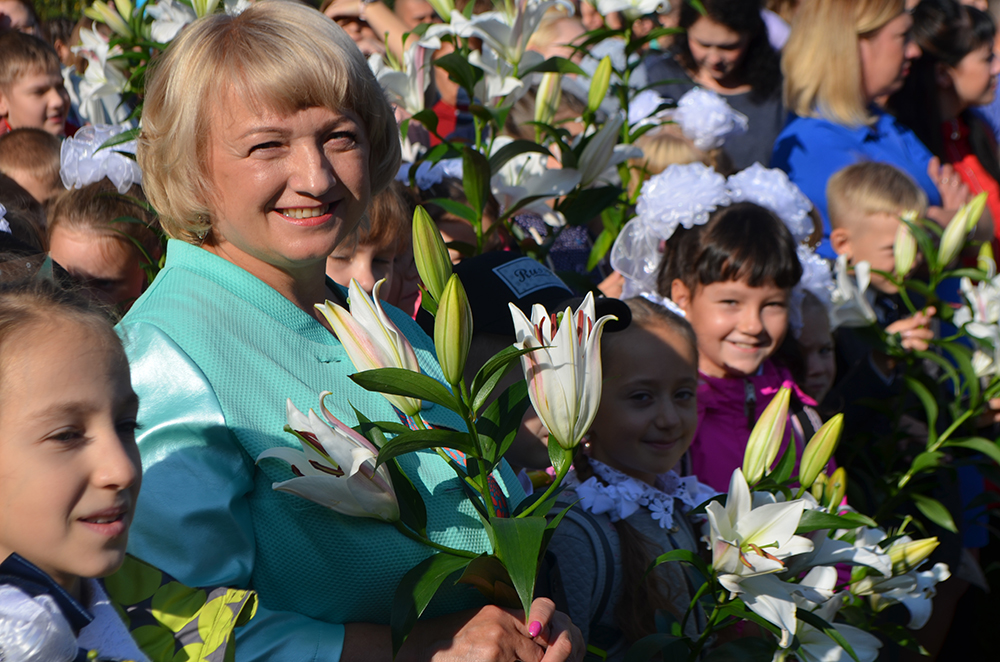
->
[0,281,147,661]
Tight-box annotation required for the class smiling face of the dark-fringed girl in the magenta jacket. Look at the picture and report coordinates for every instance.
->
[670,280,789,377]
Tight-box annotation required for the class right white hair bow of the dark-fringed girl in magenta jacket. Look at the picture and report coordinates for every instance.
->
[728,163,813,244]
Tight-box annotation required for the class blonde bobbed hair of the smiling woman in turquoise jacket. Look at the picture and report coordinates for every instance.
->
[137,0,400,244]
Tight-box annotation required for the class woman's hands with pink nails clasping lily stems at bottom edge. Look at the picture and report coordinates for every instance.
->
[341,598,586,662]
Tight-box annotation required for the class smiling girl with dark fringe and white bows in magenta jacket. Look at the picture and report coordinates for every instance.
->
[658,202,815,490]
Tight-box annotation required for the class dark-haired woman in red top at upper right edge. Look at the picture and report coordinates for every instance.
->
[889,0,1000,244]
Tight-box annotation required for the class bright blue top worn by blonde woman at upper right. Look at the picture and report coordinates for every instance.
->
[771,109,941,259]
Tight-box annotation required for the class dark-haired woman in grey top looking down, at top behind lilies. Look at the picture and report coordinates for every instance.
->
[647,0,785,170]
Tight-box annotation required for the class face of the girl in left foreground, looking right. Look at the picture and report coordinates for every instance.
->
[0,315,141,593]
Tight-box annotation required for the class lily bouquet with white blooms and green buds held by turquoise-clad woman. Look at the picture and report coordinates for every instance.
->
[258,207,613,651]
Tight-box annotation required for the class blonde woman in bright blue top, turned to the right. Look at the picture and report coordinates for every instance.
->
[771,0,968,259]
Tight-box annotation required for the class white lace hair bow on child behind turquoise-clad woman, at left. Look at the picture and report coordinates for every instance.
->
[59,124,142,194]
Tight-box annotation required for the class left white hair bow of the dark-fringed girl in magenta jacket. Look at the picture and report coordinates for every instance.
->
[611,163,730,298]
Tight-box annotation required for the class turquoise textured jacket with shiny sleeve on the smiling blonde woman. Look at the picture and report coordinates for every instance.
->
[118,240,524,662]
